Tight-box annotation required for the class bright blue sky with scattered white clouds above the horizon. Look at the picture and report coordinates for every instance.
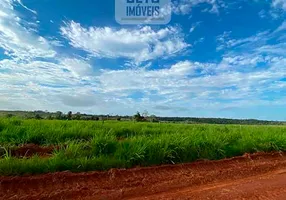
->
[0,0,286,120]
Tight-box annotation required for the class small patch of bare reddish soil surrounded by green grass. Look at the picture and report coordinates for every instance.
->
[11,144,59,157]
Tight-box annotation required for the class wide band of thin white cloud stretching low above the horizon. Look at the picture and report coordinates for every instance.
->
[0,56,286,115]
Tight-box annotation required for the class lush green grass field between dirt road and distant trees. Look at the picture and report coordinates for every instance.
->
[0,118,286,175]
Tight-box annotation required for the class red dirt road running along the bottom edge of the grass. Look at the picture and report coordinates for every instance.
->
[0,153,286,200]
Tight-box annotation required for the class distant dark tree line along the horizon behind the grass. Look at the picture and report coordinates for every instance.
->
[0,111,286,125]
